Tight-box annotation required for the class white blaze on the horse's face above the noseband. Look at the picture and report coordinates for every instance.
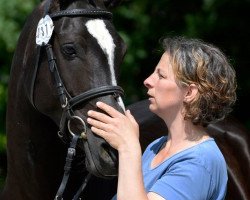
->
[86,19,117,85]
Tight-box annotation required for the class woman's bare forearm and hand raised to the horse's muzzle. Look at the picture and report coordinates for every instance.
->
[88,102,163,200]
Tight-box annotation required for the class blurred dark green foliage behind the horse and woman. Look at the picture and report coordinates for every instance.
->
[0,0,250,189]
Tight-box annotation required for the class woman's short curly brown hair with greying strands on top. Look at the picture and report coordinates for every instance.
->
[161,37,236,126]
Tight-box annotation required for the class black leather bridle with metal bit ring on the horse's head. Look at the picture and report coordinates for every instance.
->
[30,0,123,200]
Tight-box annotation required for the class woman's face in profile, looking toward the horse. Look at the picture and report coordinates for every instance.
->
[144,53,187,119]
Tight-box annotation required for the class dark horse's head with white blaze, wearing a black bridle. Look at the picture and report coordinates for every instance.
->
[26,0,126,177]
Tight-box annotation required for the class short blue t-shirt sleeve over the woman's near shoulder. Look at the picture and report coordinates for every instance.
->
[149,161,213,200]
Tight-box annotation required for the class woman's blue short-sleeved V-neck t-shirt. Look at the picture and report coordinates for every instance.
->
[142,137,228,200]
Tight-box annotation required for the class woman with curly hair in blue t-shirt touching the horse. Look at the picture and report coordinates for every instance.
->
[88,38,236,200]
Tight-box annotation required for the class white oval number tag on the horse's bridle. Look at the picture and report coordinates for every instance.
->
[36,15,54,46]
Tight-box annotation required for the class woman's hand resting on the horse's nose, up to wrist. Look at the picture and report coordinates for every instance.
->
[87,102,140,151]
